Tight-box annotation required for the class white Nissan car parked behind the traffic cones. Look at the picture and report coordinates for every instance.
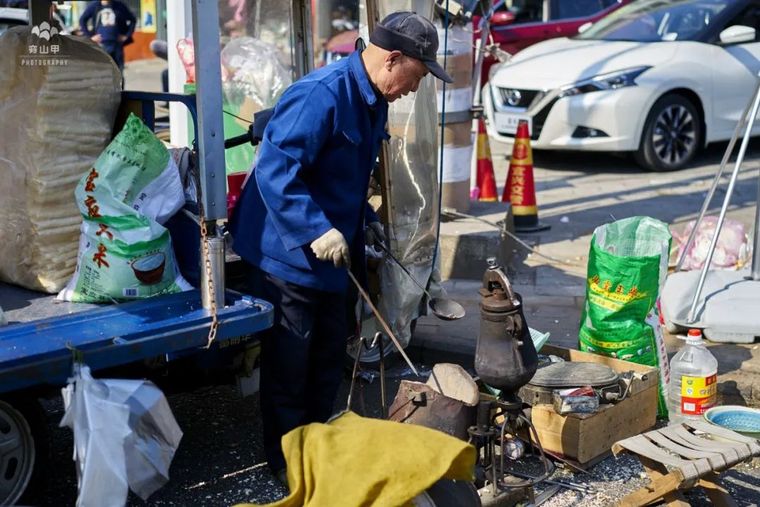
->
[483,0,760,171]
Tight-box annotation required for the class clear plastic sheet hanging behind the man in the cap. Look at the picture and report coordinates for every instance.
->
[360,0,443,346]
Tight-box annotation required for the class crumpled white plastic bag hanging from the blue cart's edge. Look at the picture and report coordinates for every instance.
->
[60,365,182,507]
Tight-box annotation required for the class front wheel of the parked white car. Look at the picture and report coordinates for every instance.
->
[635,95,702,171]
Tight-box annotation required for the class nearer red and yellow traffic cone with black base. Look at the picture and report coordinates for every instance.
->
[501,120,550,232]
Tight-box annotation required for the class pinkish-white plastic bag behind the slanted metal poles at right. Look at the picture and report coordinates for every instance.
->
[673,216,750,271]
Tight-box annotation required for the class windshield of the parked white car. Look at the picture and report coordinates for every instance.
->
[576,0,731,42]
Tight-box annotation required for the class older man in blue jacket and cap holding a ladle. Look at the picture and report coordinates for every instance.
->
[230,12,451,477]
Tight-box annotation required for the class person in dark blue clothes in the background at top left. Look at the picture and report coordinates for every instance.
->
[79,0,136,70]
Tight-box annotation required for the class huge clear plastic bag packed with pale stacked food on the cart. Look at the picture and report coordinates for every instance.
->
[0,27,121,293]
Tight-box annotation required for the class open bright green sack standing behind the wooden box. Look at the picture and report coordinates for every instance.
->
[579,217,671,416]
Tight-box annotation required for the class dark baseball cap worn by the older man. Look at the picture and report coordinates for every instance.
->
[369,11,454,83]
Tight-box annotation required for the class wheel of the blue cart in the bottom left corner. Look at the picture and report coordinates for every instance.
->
[0,399,50,505]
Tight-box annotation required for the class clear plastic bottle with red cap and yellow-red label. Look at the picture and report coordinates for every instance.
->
[668,329,718,422]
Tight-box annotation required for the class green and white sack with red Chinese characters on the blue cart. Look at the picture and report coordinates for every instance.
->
[58,115,192,303]
